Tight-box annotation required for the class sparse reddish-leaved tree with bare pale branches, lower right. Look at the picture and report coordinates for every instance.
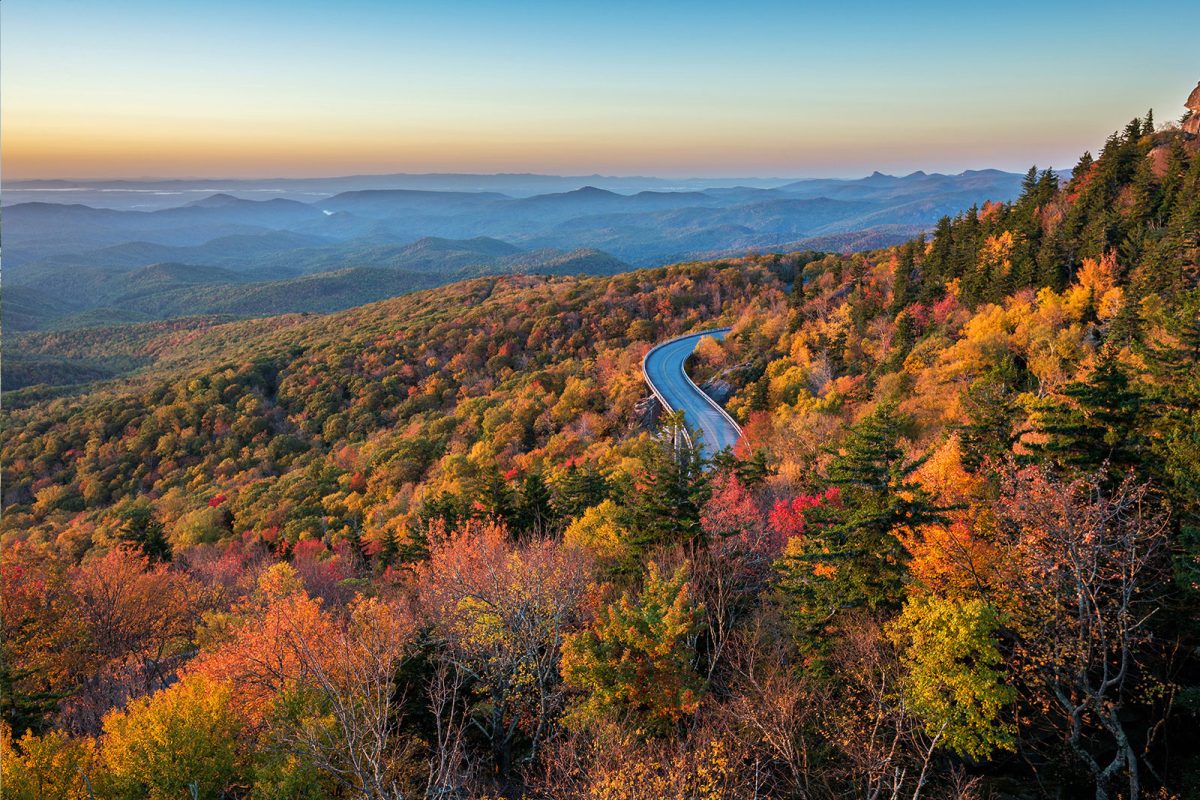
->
[994,467,1168,800]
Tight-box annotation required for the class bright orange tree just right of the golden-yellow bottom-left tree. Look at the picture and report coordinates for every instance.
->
[190,564,416,800]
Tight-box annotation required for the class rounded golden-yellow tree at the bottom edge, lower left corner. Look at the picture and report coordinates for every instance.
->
[101,676,246,800]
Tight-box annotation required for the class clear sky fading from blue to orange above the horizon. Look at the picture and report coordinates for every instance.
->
[0,0,1200,180]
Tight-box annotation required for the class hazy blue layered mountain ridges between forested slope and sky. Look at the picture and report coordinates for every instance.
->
[2,170,1021,330]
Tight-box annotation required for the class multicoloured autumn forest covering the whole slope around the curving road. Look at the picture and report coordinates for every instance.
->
[0,103,1200,800]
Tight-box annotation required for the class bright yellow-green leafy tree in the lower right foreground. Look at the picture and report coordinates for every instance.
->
[889,595,1016,759]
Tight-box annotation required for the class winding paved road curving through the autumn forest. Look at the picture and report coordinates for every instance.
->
[642,327,742,458]
